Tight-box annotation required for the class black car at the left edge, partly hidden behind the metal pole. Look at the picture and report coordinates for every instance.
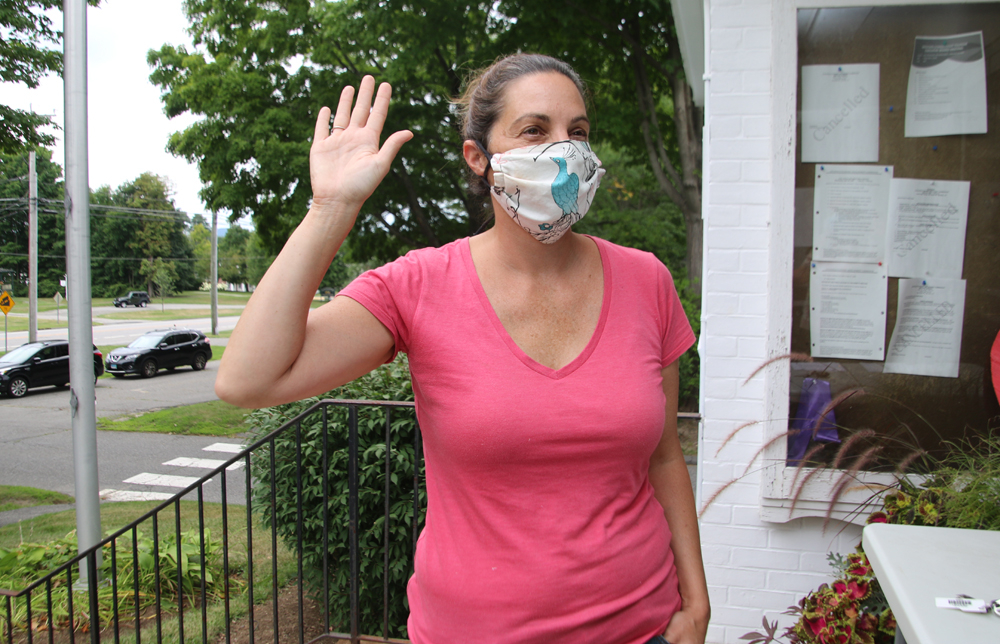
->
[0,340,104,398]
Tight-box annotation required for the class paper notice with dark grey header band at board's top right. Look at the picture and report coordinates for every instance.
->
[905,31,986,137]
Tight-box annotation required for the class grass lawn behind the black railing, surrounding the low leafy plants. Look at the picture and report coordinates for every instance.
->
[0,501,296,644]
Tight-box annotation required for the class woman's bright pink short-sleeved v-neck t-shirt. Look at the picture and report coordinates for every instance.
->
[341,238,694,644]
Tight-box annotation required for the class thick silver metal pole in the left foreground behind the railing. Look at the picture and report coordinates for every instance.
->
[63,0,101,588]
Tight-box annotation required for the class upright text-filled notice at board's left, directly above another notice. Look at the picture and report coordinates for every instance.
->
[813,164,892,264]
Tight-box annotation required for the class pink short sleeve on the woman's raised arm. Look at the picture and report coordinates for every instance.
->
[338,254,423,361]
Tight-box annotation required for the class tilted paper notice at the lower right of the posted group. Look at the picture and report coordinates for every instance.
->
[882,279,965,378]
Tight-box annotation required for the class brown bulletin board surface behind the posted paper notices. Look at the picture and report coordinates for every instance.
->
[789,3,1000,470]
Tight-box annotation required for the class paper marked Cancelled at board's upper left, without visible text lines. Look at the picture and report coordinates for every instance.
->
[801,63,879,163]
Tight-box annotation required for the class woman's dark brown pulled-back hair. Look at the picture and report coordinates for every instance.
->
[454,54,587,197]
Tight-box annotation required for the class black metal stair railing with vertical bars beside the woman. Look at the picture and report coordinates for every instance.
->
[0,400,423,644]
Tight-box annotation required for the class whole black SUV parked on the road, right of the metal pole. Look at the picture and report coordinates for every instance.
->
[104,329,212,378]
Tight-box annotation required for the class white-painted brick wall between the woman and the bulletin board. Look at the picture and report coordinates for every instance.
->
[699,0,860,644]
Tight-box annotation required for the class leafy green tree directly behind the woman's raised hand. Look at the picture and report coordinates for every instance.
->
[149,0,508,260]
